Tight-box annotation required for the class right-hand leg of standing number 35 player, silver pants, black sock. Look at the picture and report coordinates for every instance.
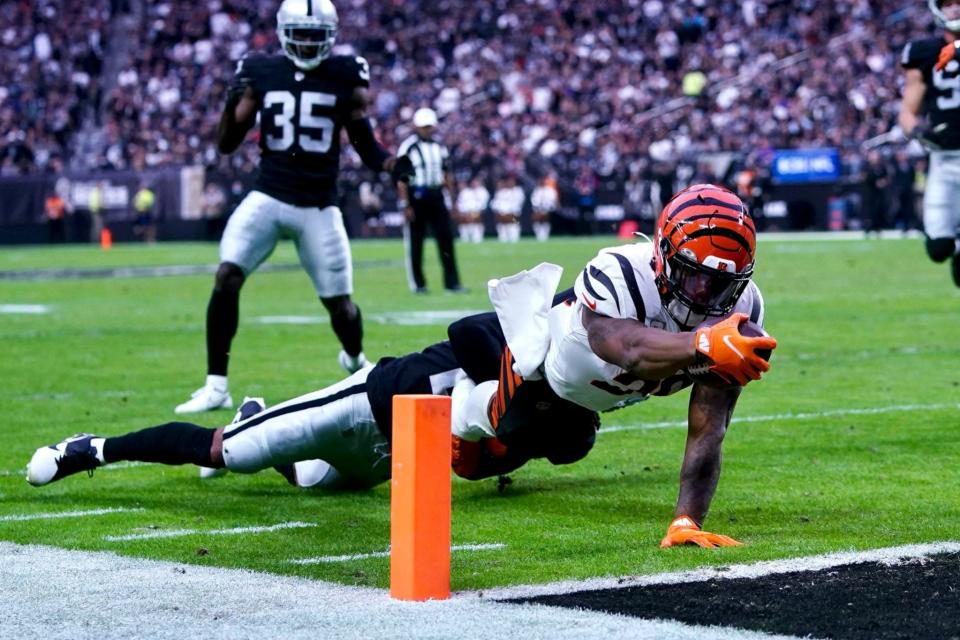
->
[295,207,367,373]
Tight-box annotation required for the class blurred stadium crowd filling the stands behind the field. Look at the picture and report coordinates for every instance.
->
[0,0,932,212]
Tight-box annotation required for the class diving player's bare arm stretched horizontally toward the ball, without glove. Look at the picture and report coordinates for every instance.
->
[583,308,697,380]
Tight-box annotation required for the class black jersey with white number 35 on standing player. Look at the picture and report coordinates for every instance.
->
[234,54,370,207]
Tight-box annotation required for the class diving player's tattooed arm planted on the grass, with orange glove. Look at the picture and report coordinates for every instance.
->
[660,385,740,547]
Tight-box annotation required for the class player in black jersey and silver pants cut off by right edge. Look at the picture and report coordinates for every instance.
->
[899,0,960,287]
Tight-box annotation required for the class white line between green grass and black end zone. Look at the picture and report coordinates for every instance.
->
[472,540,960,600]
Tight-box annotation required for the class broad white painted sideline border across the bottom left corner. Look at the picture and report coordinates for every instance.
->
[0,543,796,640]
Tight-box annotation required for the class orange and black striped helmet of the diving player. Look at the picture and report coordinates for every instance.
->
[653,184,757,327]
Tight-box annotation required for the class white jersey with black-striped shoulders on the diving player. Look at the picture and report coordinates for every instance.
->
[544,243,763,411]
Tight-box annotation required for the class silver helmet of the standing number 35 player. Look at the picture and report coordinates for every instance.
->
[277,0,338,70]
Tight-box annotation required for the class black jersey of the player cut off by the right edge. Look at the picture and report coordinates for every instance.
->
[901,36,960,149]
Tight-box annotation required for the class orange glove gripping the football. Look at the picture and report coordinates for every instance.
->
[694,313,777,385]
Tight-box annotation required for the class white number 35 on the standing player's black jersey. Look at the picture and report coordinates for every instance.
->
[263,91,337,153]
